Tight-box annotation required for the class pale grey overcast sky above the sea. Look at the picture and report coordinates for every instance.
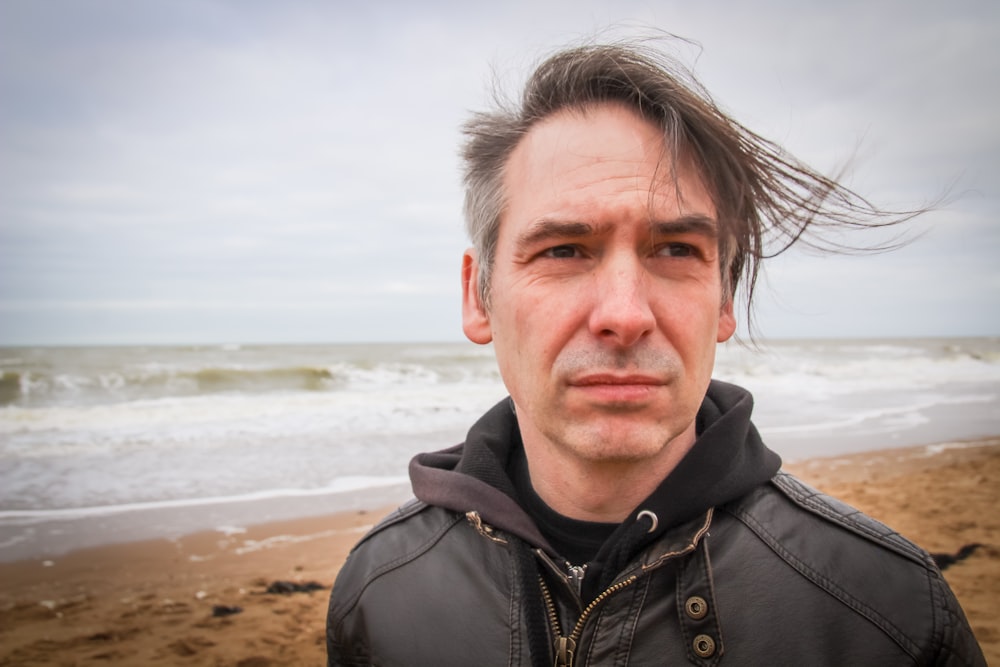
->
[0,0,1000,344]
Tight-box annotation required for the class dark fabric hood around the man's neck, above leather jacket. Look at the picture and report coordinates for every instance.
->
[410,380,781,556]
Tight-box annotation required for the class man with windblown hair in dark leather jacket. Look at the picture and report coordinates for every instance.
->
[327,41,985,665]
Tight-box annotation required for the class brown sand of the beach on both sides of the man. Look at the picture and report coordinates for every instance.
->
[0,438,1000,667]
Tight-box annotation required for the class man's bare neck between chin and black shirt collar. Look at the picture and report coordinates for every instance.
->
[524,424,696,523]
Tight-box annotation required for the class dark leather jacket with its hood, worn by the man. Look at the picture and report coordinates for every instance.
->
[327,383,986,667]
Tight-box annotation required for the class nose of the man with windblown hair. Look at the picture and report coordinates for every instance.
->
[590,256,656,347]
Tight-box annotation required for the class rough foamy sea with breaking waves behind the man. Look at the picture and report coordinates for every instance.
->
[0,338,1000,561]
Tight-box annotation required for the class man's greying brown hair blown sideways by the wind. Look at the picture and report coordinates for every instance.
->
[462,36,920,332]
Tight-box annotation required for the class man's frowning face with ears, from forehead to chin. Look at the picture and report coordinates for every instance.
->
[463,105,736,470]
